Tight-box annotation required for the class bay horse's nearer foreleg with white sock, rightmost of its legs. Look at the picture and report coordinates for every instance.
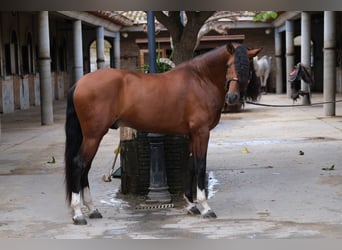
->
[193,130,216,218]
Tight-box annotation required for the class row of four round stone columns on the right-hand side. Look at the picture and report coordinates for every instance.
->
[274,11,336,116]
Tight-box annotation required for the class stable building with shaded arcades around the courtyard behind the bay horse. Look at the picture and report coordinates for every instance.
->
[0,11,342,116]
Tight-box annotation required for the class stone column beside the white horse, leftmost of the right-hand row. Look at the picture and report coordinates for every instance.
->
[274,29,283,94]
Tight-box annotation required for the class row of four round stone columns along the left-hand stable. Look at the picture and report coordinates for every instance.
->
[38,11,120,125]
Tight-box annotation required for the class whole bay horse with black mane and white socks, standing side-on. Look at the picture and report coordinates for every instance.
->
[65,43,261,224]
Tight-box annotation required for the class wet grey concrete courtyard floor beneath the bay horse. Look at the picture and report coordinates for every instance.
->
[0,94,342,239]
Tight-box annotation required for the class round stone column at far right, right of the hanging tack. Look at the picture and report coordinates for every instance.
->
[323,11,336,116]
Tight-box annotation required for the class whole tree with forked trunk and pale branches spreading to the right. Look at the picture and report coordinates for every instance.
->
[154,11,278,64]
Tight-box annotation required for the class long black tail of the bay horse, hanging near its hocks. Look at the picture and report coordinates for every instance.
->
[64,86,83,204]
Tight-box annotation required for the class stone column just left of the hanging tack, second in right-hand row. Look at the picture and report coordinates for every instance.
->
[285,20,295,98]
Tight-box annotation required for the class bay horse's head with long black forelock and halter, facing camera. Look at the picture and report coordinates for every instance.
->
[225,43,261,105]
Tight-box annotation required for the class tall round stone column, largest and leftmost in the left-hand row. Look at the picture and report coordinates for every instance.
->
[38,11,53,125]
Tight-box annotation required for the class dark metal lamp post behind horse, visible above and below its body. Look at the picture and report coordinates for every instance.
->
[146,11,171,203]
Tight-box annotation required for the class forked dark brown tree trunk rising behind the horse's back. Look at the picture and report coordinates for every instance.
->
[154,11,215,64]
